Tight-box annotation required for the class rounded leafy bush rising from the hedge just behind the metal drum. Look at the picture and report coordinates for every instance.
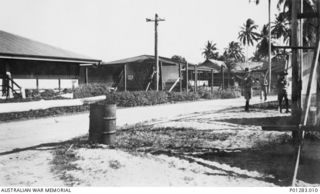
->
[73,83,111,98]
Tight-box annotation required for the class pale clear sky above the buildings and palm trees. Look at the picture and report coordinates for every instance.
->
[0,0,277,63]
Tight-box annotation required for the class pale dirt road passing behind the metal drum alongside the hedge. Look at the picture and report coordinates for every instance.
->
[0,97,275,154]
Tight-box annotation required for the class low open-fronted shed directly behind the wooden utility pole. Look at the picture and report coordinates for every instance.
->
[80,55,180,91]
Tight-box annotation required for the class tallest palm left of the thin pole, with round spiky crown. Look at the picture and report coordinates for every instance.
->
[238,18,260,60]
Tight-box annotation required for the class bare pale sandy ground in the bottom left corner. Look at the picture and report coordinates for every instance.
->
[0,150,65,187]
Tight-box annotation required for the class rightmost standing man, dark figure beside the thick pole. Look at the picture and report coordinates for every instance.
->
[277,71,289,113]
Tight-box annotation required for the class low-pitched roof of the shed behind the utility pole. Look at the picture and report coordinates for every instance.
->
[101,55,178,65]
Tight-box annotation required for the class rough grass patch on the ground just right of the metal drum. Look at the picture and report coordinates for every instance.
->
[114,127,235,152]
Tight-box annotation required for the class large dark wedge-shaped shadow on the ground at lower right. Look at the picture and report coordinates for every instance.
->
[192,142,320,186]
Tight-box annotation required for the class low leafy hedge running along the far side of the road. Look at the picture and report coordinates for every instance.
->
[0,87,240,121]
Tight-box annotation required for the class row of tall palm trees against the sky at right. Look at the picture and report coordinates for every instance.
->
[176,0,318,88]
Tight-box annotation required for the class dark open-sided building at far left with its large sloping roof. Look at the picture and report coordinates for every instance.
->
[0,31,100,96]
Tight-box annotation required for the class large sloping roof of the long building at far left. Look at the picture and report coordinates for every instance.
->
[0,30,100,63]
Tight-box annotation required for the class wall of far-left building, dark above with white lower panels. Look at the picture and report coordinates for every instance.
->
[0,59,80,89]
